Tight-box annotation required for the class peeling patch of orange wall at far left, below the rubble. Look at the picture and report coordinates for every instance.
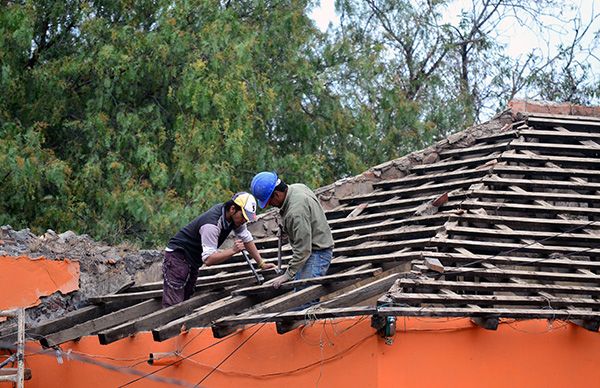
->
[0,256,79,310]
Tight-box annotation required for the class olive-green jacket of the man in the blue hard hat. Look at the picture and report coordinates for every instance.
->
[279,183,333,278]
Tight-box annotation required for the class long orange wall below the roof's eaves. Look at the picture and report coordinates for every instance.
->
[8,318,600,388]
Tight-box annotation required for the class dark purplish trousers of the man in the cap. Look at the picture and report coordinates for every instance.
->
[162,250,198,307]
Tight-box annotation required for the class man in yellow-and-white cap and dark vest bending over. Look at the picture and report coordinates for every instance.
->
[162,192,275,307]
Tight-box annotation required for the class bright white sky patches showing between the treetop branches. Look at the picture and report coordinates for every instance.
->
[311,0,600,76]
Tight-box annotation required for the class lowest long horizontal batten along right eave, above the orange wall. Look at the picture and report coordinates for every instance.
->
[377,306,600,320]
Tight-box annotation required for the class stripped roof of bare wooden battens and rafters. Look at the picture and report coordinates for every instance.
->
[5,101,600,346]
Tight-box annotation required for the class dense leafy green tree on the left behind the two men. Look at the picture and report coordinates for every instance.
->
[0,0,365,245]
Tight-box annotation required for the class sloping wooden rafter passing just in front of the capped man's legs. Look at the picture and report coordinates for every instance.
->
[98,292,228,345]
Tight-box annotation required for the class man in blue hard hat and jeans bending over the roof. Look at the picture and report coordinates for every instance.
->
[250,171,333,298]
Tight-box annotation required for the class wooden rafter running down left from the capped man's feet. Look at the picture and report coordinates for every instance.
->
[40,299,161,347]
